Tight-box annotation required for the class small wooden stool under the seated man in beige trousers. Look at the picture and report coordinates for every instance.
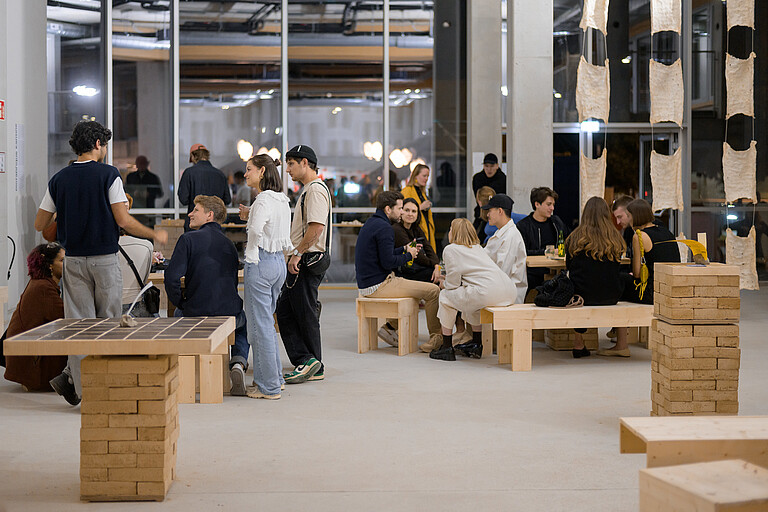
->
[355,297,419,356]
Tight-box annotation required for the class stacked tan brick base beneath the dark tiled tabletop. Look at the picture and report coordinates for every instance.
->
[80,356,179,501]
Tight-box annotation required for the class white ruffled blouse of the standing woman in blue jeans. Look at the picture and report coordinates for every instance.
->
[245,190,293,264]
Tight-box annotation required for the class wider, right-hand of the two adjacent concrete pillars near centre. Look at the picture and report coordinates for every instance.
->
[507,0,552,213]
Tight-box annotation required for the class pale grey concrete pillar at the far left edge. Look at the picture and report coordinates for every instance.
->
[0,0,48,309]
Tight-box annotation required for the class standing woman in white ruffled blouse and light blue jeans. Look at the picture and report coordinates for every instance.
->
[236,155,293,400]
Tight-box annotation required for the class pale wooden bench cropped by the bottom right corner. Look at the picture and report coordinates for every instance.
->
[640,460,768,512]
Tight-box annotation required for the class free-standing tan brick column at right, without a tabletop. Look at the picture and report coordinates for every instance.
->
[650,263,741,416]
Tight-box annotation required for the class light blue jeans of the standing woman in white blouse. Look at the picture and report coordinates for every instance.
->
[243,249,286,395]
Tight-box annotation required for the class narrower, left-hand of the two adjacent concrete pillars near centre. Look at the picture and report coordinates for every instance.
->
[466,0,504,214]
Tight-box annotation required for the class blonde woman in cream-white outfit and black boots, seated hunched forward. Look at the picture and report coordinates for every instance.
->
[429,218,517,361]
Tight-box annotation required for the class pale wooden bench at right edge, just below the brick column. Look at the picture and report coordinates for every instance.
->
[620,416,768,468]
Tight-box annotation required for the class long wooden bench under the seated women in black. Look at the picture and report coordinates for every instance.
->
[481,302,653,371]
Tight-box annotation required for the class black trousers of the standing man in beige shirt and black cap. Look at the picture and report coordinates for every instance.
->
[275,267,325,366]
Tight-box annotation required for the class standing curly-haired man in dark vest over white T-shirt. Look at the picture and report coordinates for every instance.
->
[35,121,168,405]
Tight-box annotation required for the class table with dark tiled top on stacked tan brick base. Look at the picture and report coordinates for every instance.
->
[5,317,235,501]
